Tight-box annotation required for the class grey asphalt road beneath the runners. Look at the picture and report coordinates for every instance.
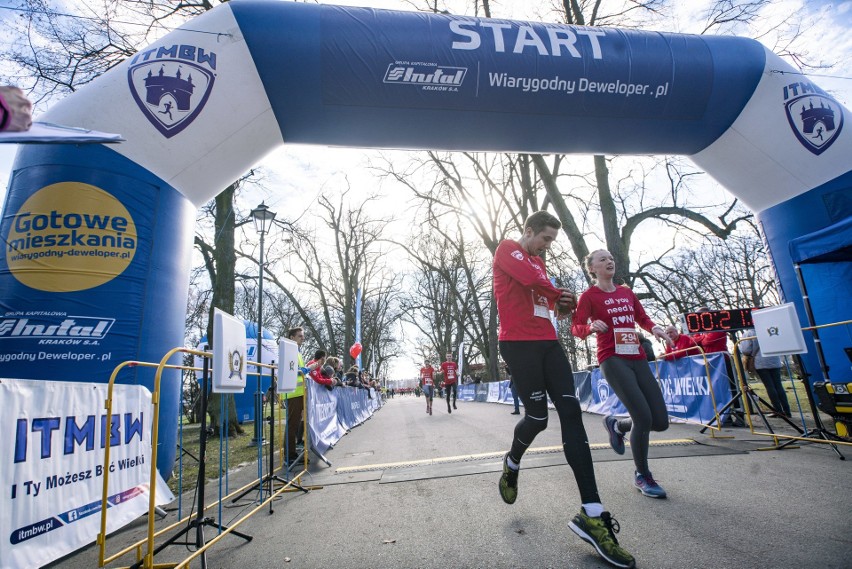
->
[50,396,852,569]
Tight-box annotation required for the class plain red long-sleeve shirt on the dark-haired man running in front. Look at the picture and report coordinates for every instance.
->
[493,239,562,341]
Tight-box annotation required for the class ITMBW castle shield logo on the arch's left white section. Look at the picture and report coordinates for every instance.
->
[127,45,216,138]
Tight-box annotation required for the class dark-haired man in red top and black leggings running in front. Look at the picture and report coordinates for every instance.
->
[493,211,635,568]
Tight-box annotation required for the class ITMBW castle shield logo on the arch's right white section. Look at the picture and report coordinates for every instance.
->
[783,81,844,156]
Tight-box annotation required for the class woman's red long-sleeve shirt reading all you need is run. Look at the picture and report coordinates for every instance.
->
[571,286,655,363]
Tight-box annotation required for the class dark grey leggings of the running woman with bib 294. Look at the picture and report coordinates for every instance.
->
[601,356,669,475]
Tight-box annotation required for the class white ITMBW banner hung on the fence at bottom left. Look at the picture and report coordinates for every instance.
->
[0,379,174,569]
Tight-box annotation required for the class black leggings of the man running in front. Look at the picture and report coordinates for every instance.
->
[500,340,601,504]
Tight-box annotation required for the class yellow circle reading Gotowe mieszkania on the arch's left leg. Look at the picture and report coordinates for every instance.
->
[6,182,137,292]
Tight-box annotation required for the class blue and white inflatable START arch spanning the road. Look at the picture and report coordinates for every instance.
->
[0,0,852,471]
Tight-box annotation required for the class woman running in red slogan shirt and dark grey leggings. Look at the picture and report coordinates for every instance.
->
[571,249,672,498]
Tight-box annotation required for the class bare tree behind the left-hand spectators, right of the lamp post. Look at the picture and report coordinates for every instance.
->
[256,189,400,375]
